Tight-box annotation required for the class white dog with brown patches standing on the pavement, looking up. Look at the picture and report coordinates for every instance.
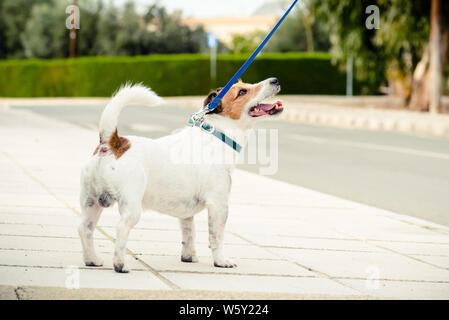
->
[78,78,283,273]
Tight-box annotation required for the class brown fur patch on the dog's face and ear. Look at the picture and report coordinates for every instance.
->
[203,81,262,120]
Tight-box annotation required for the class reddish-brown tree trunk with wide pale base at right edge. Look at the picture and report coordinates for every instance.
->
[409,0,448,113]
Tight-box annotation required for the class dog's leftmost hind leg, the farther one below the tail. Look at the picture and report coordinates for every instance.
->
[78,196,103,267]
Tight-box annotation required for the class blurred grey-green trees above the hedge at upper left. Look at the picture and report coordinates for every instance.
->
[0,0,206,58]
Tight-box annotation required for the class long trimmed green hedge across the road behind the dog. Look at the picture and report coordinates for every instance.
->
[0,53,352,97]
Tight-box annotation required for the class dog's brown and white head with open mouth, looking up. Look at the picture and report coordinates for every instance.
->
[203,78,283,120]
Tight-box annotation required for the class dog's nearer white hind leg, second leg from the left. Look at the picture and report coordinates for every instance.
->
[113,201,142,273]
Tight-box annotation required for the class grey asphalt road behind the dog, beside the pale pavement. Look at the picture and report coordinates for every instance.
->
[16,106,449,225]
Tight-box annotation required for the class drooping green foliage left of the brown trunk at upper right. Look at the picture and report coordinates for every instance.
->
[312,0,449,92]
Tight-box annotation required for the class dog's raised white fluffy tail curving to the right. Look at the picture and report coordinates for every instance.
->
[100,83,163,142]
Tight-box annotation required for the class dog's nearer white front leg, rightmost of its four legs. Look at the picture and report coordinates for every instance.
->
[208,204,237,268]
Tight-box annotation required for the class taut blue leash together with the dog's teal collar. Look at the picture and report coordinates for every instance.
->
[189,0,298,152]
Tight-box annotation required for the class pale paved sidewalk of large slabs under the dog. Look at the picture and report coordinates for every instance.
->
[0,109,449,299]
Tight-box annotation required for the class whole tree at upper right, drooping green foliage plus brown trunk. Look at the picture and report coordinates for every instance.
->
[313,0,449,112]
